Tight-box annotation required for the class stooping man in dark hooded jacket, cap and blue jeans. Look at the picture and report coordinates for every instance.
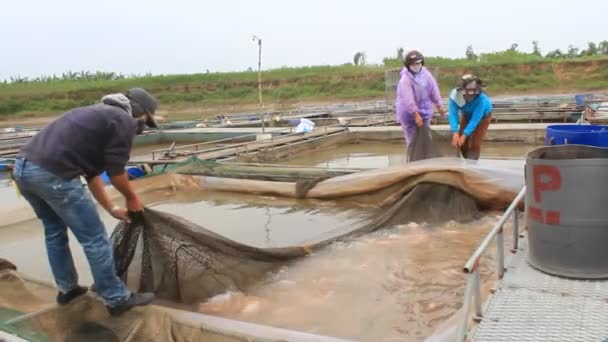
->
[13,88,157,316]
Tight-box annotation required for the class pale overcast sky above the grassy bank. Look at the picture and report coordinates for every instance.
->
[0,0,608,79]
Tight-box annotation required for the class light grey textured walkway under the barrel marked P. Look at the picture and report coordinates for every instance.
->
[470,236,608,342]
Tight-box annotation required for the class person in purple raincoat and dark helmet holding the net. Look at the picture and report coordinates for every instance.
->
[395,50,445,145]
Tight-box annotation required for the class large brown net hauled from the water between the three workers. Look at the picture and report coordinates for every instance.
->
[112,126,523,303]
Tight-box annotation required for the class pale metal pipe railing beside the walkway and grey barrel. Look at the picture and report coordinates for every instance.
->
[456,186,526,342]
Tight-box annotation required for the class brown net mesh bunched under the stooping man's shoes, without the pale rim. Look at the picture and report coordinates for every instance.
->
[0,270,242,342]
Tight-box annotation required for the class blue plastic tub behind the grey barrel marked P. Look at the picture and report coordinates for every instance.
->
[545,125,608,147]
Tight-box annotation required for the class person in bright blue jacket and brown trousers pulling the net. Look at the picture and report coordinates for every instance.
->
[448,75,492,159]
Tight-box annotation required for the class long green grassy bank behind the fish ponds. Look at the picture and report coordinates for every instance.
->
[0,53,608,120]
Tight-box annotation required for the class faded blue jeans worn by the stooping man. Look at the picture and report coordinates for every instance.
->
[13,158,130,306]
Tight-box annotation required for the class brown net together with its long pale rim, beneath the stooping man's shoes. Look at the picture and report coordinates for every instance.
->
[0,269,340,342]
